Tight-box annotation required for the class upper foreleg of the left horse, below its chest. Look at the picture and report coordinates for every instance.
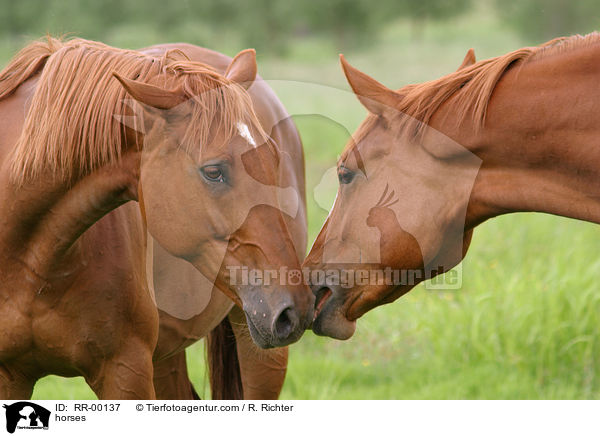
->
[86,338,156,400]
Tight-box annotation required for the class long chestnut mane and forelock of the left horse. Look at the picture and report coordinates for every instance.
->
[0,37,266,183]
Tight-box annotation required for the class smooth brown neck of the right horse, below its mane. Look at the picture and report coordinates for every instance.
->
[434,45,600,228]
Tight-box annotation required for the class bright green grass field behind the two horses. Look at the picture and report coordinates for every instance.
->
[0,11,600,399]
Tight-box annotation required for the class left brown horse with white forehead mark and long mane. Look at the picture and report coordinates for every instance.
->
[0,40,312,398]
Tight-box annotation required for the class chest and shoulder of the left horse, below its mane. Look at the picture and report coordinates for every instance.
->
[0,117,158,398]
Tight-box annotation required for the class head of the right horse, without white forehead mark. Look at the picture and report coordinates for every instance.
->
[304,52,479,339]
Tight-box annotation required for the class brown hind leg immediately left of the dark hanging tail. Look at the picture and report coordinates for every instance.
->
[154,350,200,400]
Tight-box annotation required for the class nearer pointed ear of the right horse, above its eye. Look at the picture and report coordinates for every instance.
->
[340,55,402,115]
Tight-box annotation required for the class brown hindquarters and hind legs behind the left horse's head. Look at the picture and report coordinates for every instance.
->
[143,44,306,399]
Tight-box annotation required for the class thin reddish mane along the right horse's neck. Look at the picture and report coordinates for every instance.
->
[390,32,600,138]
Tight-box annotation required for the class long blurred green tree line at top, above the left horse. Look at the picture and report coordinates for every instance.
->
[0,0,480,52]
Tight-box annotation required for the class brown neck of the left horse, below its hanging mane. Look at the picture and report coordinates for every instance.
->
[0,148,140,280]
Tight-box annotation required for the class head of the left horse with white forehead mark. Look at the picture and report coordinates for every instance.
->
[117,50,313,348]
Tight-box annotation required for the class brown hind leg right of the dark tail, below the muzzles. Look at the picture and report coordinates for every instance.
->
[229,306,288,400]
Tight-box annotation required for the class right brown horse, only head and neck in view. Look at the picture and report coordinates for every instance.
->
[305,34,600,339]
